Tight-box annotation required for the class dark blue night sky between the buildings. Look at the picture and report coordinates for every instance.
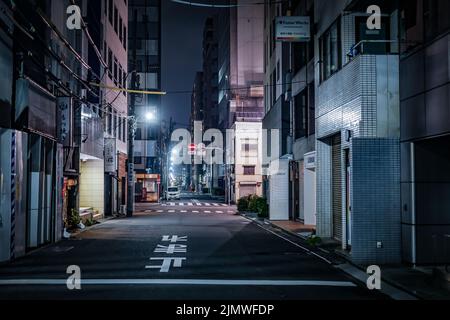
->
[161,0,217,124]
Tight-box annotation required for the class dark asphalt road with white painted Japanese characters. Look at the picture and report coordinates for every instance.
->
[0,198,385,300]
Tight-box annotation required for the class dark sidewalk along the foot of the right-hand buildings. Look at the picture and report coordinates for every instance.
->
[244,213,450,300]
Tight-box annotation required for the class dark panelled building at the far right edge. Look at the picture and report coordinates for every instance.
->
[400,1,450,265]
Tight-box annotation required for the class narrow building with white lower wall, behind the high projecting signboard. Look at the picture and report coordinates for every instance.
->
[263,1,316,225]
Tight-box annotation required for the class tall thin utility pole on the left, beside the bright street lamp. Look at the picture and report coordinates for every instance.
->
[127,10,137,217]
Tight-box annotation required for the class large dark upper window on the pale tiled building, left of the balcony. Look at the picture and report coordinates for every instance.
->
[319,20,342,81]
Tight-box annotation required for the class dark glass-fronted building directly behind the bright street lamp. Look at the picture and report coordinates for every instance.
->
[128,0,165,202]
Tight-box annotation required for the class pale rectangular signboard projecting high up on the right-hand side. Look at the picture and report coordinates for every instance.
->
[275,16,311,42]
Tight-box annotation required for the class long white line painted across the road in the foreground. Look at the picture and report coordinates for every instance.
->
[0,279,356,287]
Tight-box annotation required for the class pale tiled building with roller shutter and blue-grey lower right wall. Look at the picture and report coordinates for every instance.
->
[315,1,401,264]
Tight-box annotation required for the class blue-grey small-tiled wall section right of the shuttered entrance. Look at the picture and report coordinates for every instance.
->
[351,138,401,264]
